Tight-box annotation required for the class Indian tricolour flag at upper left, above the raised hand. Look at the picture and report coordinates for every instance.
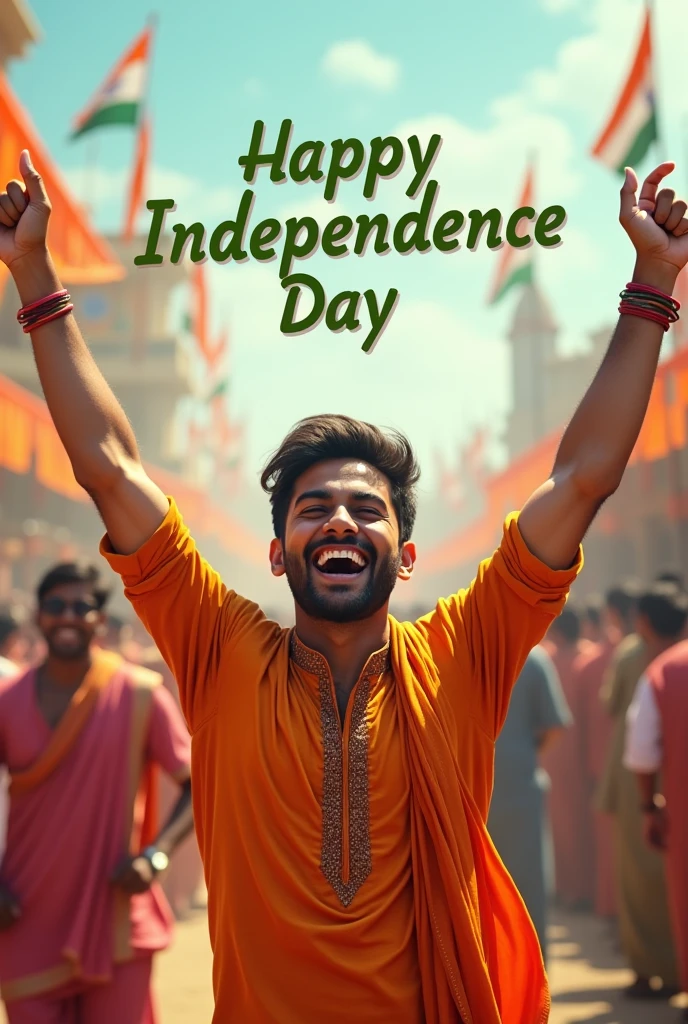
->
[72,27,153,138]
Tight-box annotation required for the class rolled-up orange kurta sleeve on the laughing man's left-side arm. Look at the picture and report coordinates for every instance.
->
[100,499,261,733]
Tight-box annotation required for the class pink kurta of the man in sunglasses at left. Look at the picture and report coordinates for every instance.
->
[0,666,190,1001]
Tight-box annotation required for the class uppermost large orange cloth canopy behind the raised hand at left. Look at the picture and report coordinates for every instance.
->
[0,73,125,285]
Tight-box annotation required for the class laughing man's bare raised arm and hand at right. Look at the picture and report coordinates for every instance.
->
[519,163,688,569]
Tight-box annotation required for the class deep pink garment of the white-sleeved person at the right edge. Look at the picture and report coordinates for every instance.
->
[647,640,688,991]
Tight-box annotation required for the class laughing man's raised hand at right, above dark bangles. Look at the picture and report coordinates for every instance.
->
[618,162,688,290]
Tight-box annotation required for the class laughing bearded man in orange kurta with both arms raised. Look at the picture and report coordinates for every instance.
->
[0,153,688,1024]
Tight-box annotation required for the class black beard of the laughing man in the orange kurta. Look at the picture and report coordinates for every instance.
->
[284,552,401,623]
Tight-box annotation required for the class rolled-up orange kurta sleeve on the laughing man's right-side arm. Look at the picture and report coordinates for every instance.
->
[416,513,583,739]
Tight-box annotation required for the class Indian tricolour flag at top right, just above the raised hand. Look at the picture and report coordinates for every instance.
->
[592,10,657,174]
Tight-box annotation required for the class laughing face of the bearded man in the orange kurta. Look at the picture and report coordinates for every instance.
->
[270,459,416,623]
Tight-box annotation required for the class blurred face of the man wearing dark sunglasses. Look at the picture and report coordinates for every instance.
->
[36,583,104,660]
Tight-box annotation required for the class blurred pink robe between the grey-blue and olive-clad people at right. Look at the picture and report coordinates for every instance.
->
[542,641,598,906]
